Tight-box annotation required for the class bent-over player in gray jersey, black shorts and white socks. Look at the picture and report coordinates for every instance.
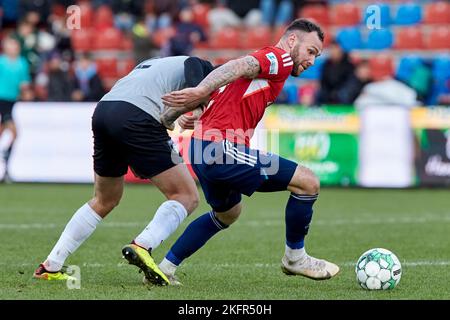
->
[34,56,213,285]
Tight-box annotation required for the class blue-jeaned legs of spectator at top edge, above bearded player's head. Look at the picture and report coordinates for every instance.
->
[260,0,294,26]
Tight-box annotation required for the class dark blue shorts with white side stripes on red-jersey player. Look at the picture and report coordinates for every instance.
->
[189,138,297,212]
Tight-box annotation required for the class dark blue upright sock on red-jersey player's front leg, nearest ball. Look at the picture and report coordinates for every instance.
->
[285,193,318,249]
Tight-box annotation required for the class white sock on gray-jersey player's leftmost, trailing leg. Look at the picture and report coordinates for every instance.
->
[44,203,102,271]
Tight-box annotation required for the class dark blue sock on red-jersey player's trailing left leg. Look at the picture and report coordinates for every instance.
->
[166,211,228,266]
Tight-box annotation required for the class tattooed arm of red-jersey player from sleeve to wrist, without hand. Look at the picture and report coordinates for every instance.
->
[199,56,260,93]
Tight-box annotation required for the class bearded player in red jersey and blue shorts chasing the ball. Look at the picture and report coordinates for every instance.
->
[159,19,339,284]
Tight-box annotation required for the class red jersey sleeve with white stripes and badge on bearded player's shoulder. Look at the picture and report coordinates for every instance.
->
[250,47,294,81]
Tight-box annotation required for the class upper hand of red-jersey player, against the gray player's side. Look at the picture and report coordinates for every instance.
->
[161,88,209,110]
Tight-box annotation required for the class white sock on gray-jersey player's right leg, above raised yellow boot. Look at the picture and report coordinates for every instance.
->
[134,200,187,250]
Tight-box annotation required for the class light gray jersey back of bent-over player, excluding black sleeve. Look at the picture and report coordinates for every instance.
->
[100,56,189,122]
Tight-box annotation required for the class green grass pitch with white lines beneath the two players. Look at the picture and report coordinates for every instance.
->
[0,184,450,300]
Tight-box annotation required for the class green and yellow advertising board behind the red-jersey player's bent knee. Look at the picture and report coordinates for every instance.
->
[264,106,359,185]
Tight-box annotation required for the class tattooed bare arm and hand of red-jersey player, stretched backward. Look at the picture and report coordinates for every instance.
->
[162,56,260,112]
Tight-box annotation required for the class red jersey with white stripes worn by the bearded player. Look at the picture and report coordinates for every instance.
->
[194,47,294,146]
